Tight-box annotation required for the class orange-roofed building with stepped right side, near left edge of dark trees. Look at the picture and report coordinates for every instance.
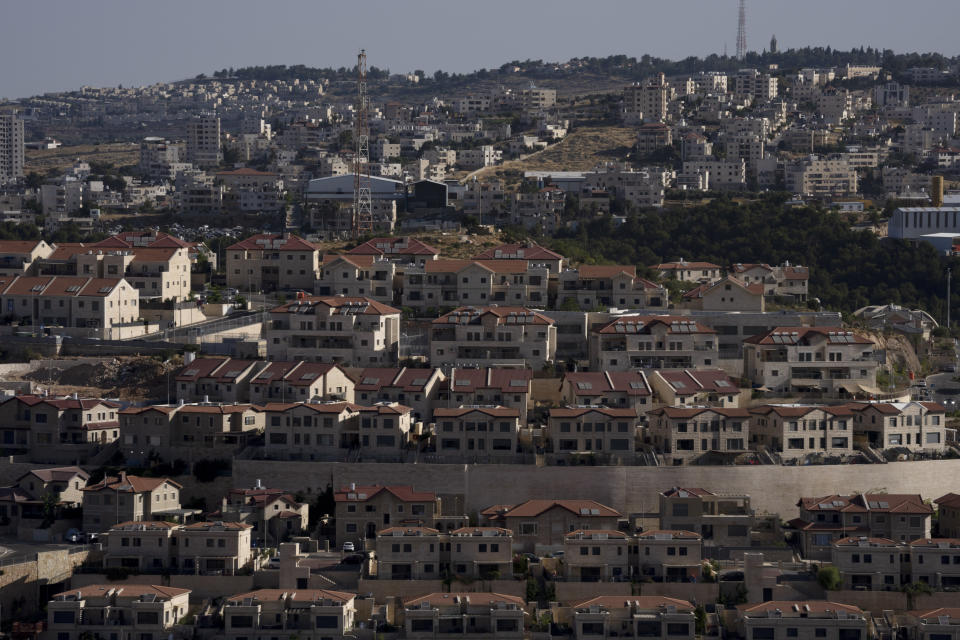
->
[557,264,670,311]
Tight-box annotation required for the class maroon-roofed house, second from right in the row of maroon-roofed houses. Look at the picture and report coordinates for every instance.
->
[560,371,654,421]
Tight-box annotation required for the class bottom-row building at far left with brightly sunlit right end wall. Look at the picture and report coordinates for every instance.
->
[46,583,190,640]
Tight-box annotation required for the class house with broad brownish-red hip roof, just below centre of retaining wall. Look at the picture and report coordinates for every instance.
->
[480,500,623,553]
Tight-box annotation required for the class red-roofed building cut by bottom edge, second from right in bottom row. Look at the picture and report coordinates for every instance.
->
[736,600,871,640]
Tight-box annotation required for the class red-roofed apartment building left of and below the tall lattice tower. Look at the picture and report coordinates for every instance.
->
[226,233,320,292]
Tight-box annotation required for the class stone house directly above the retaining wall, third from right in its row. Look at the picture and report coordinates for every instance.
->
[647,407,751,465]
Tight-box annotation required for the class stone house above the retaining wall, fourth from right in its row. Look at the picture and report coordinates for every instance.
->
[547,406,640,461]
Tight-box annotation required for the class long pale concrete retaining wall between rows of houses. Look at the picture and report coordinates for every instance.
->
[233,459,960,520]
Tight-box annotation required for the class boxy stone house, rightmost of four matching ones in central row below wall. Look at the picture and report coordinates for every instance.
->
[636,529,703,582]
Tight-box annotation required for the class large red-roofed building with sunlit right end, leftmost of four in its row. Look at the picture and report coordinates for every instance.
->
[266,296,400,366]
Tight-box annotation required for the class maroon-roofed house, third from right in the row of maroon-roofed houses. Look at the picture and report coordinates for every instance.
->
[433,367,533,425]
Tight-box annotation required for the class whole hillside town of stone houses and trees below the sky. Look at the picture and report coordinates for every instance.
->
[7,0,960,640]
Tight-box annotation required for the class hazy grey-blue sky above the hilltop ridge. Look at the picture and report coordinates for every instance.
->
[0,0,960,98]
